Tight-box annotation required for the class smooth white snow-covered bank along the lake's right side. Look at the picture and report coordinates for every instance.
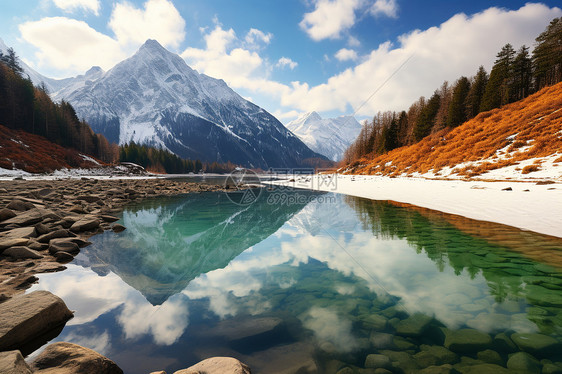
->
[268,175,562,237]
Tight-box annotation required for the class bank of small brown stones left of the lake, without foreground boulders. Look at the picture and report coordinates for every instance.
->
[0,177,223,302]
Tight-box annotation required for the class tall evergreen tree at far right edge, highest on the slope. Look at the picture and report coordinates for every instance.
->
[532,17,562,90]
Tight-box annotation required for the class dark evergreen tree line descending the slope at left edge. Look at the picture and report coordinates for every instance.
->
[0,48,118,162]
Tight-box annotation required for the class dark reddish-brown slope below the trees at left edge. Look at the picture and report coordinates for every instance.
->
[0,125,101,174]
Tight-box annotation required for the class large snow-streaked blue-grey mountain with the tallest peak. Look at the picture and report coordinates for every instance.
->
[53,40,323,169]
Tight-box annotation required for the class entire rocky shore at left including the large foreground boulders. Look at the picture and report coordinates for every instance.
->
[0,178,249,374]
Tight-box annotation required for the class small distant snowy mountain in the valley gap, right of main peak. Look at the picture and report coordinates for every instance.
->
[286,112,361,161]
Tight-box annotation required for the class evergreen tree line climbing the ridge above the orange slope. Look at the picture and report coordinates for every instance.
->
[343,17,562,164]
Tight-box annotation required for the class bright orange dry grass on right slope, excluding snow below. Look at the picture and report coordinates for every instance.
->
[350,83,562,177]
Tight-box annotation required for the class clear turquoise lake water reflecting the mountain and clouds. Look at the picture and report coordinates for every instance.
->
[28,191,562,373]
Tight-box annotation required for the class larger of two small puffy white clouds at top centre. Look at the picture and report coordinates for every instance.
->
[299,0,363,41]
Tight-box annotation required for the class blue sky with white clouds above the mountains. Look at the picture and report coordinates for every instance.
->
[0,0,562,123]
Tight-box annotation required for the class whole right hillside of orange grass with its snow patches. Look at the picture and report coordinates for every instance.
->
[343,83,562,180]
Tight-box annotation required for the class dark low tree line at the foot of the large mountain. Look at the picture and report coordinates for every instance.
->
[119,142,236,174]
